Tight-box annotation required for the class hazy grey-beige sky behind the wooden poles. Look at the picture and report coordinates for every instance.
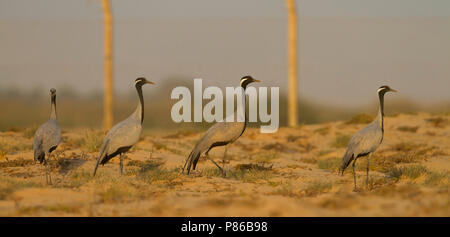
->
[0,0,450,105]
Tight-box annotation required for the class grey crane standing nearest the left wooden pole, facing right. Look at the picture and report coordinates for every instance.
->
[93,77,154,176]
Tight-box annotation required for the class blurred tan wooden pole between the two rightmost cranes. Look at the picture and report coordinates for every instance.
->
[286,0,298,127]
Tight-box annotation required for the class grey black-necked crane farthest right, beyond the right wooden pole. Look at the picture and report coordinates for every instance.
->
[341,86,397,191]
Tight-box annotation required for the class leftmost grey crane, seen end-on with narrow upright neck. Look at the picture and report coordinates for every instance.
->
[33,88,61,185]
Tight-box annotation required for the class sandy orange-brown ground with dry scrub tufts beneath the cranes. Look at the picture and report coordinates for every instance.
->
[0,114,450,216]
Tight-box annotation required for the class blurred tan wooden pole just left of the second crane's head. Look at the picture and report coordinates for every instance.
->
[102,0,114,130]
